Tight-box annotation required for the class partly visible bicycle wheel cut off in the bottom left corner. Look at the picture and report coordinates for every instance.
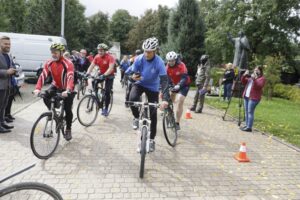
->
[0,182,63,200]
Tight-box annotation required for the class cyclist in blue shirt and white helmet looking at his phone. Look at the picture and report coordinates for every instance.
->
[129,37,170,152]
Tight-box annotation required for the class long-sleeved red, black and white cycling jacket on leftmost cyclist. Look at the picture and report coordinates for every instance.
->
[35,58,74,91]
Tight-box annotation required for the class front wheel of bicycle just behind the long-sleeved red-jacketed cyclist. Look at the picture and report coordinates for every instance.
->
[77,95,99,126]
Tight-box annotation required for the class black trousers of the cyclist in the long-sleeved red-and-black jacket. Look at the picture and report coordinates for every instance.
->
[44,85,74,129]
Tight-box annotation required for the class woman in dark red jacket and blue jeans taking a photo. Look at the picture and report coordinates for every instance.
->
[241,66,266,132]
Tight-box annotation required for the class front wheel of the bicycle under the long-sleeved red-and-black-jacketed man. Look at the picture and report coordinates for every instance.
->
[30,112,60,159]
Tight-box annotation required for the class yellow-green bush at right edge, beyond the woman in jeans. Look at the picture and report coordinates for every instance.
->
[273,83,300,103]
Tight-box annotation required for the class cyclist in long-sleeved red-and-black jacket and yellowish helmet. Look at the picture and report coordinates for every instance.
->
[34,43,74,141]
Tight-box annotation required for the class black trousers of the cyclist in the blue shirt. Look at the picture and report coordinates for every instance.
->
[129,84,159,139]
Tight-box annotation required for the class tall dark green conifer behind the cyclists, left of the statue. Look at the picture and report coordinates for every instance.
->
[166,0,205,74]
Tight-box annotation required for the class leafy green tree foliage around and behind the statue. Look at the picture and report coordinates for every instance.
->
[200,0,300,63]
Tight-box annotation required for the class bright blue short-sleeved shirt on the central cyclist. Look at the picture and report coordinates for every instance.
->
[132,54,167,92]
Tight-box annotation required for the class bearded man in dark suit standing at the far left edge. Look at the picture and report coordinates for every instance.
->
[0,36,17,134]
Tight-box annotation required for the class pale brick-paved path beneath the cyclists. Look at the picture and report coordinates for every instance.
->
[0,77,300,200]
